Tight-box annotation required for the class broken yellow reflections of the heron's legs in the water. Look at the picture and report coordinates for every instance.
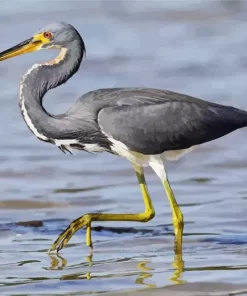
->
[49,232,185,288]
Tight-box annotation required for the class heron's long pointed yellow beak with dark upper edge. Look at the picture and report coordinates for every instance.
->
[0,38,42,61]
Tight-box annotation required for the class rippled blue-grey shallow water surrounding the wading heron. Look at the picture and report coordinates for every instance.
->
[0,0,247,295]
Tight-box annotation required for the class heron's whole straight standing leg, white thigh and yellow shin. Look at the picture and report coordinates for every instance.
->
[149,156,184,254]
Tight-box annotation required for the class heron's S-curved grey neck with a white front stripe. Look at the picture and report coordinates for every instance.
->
[19,44,83,141]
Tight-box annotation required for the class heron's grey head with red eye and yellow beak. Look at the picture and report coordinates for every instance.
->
[0,22,85,61]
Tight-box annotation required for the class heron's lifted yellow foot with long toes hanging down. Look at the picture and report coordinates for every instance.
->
[48,214,93,254]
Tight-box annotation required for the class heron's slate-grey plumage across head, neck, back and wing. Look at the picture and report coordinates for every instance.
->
[2,23,247,154]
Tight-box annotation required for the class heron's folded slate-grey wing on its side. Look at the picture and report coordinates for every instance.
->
[98,101,247,154]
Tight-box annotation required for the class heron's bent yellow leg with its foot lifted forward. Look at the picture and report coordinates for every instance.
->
[49,165,155,252]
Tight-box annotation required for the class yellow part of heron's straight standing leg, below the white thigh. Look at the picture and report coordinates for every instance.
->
[162,179,184,254]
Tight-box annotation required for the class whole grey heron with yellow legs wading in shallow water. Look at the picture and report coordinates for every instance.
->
[0,22,247,253]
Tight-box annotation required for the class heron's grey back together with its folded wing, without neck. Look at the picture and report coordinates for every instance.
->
[63,88,247,154]
